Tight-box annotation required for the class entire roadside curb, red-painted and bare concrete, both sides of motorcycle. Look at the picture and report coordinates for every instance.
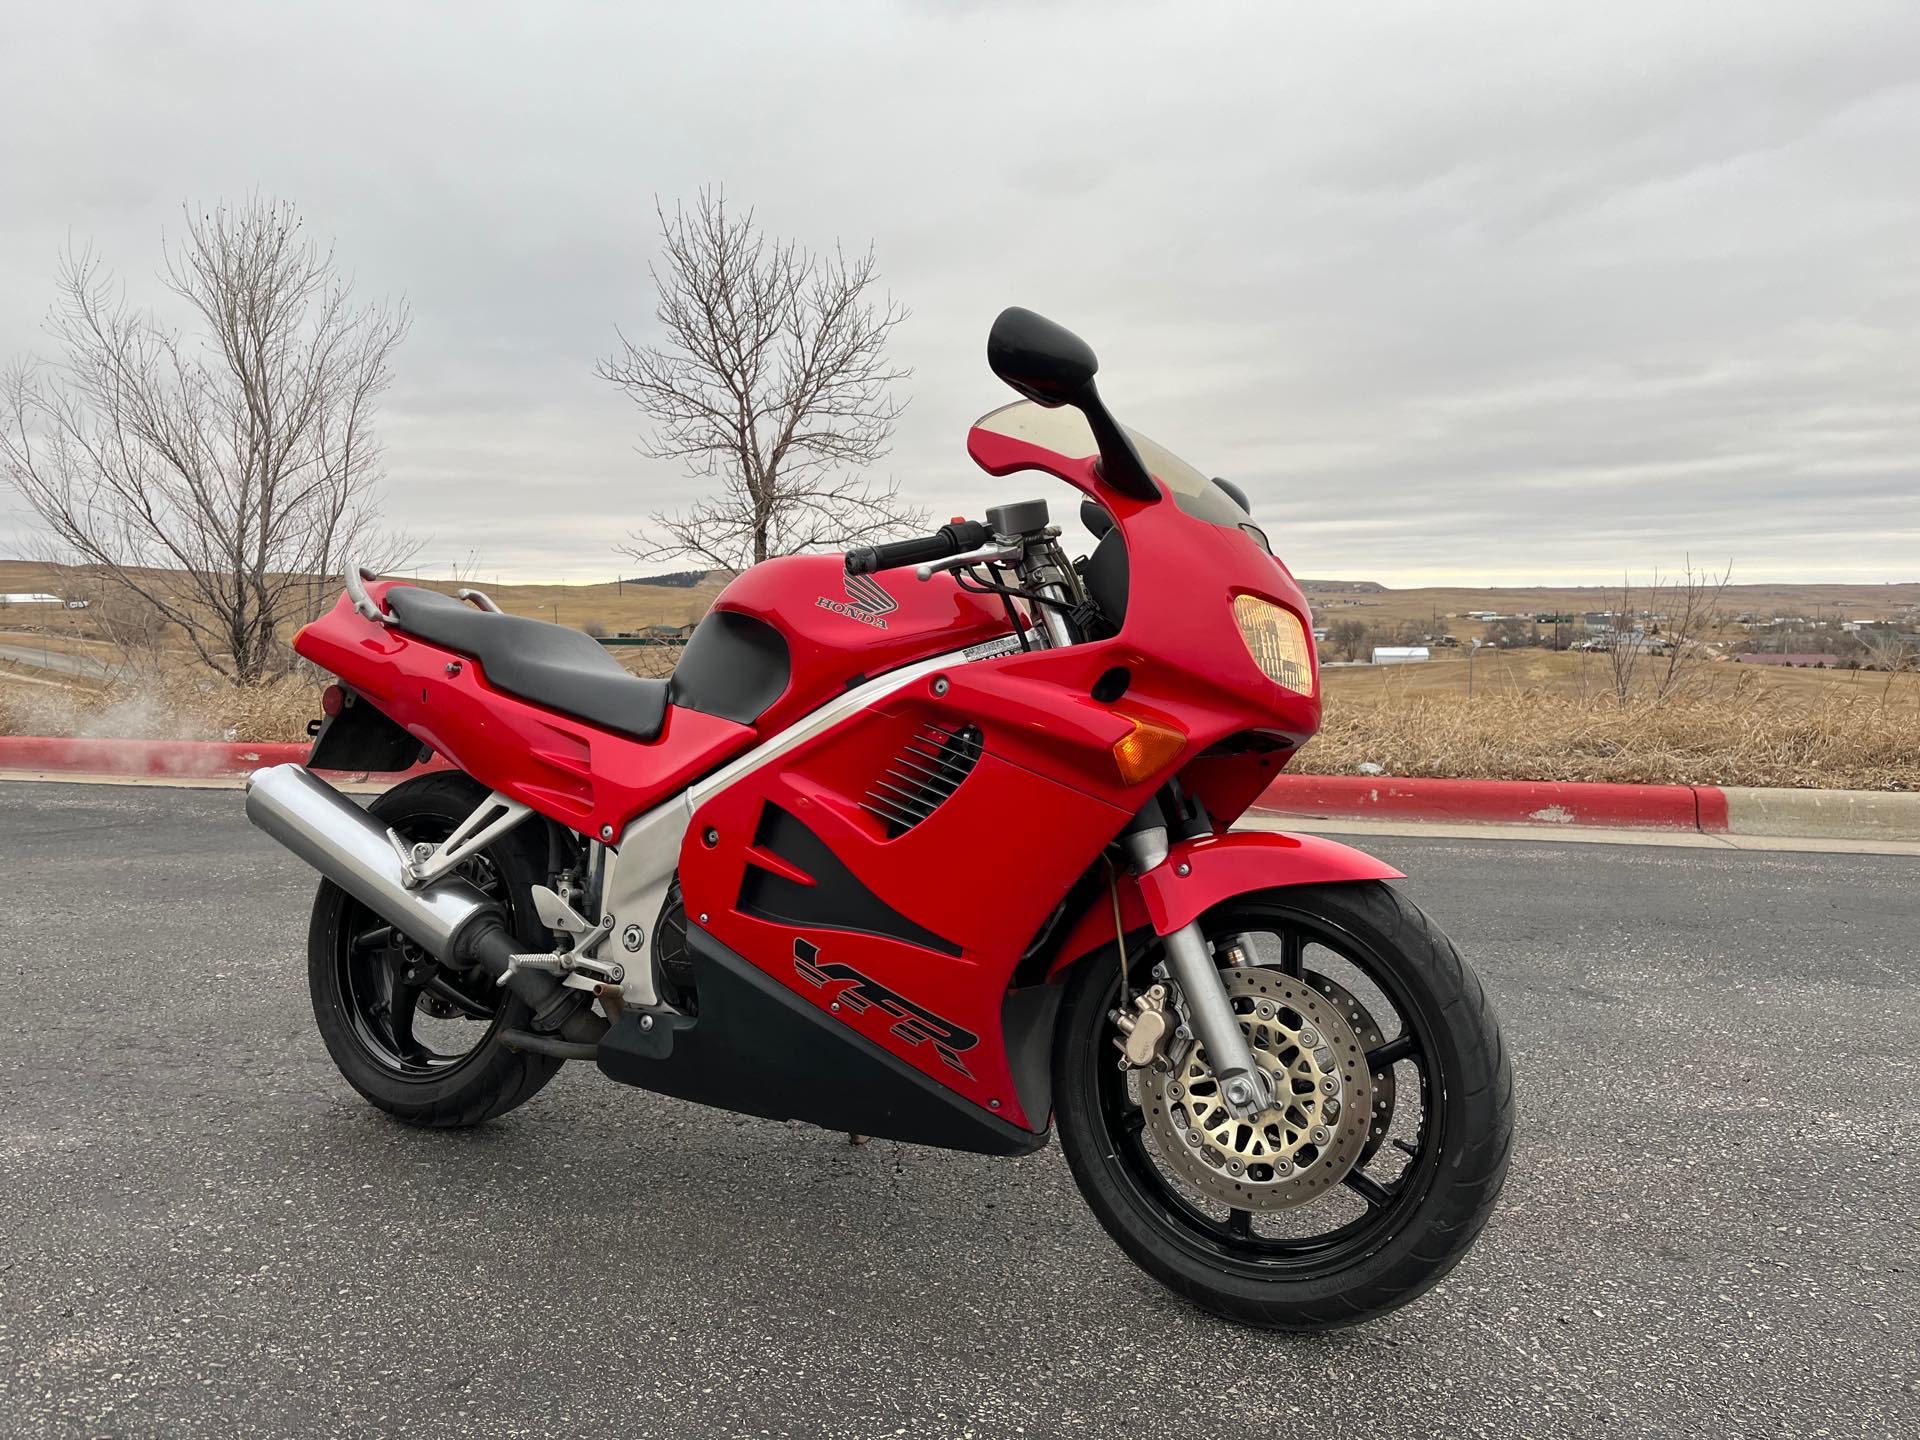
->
[0,735,1920,841]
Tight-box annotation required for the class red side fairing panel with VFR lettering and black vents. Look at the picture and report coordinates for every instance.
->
[680,683,1127,1129]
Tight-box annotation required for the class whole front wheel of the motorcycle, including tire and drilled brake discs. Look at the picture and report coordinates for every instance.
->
[1054,881,1513,1331]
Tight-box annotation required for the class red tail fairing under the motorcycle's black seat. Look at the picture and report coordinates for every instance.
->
[294,584,755,835]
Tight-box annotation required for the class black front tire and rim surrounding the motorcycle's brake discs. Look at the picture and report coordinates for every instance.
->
[1054,881,1513,1331]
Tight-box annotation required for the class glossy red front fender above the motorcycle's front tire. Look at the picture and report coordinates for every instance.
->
[1046,829,1404,979]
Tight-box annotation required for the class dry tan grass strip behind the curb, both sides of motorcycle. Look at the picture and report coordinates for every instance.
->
[0,625,1920,791]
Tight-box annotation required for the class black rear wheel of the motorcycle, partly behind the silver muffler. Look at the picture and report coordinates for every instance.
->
[307,774,563,1127]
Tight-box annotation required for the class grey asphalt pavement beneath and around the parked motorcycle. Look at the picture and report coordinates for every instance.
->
[0,783,1920,1440]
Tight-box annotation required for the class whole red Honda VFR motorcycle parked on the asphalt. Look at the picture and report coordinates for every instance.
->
[246,309,1513,1329]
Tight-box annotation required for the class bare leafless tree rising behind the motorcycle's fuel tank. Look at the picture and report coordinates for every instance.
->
[599,190,925,570]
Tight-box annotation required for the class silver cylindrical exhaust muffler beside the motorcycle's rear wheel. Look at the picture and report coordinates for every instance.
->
[246,764,499,964]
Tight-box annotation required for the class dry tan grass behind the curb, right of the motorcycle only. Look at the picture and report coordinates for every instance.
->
[1292,676,1920,789]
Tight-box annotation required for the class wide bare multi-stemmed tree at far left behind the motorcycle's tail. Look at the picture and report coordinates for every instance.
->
[0,198,407,684]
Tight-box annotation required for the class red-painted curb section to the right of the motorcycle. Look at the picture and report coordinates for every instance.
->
[1254,776,1726,831]
